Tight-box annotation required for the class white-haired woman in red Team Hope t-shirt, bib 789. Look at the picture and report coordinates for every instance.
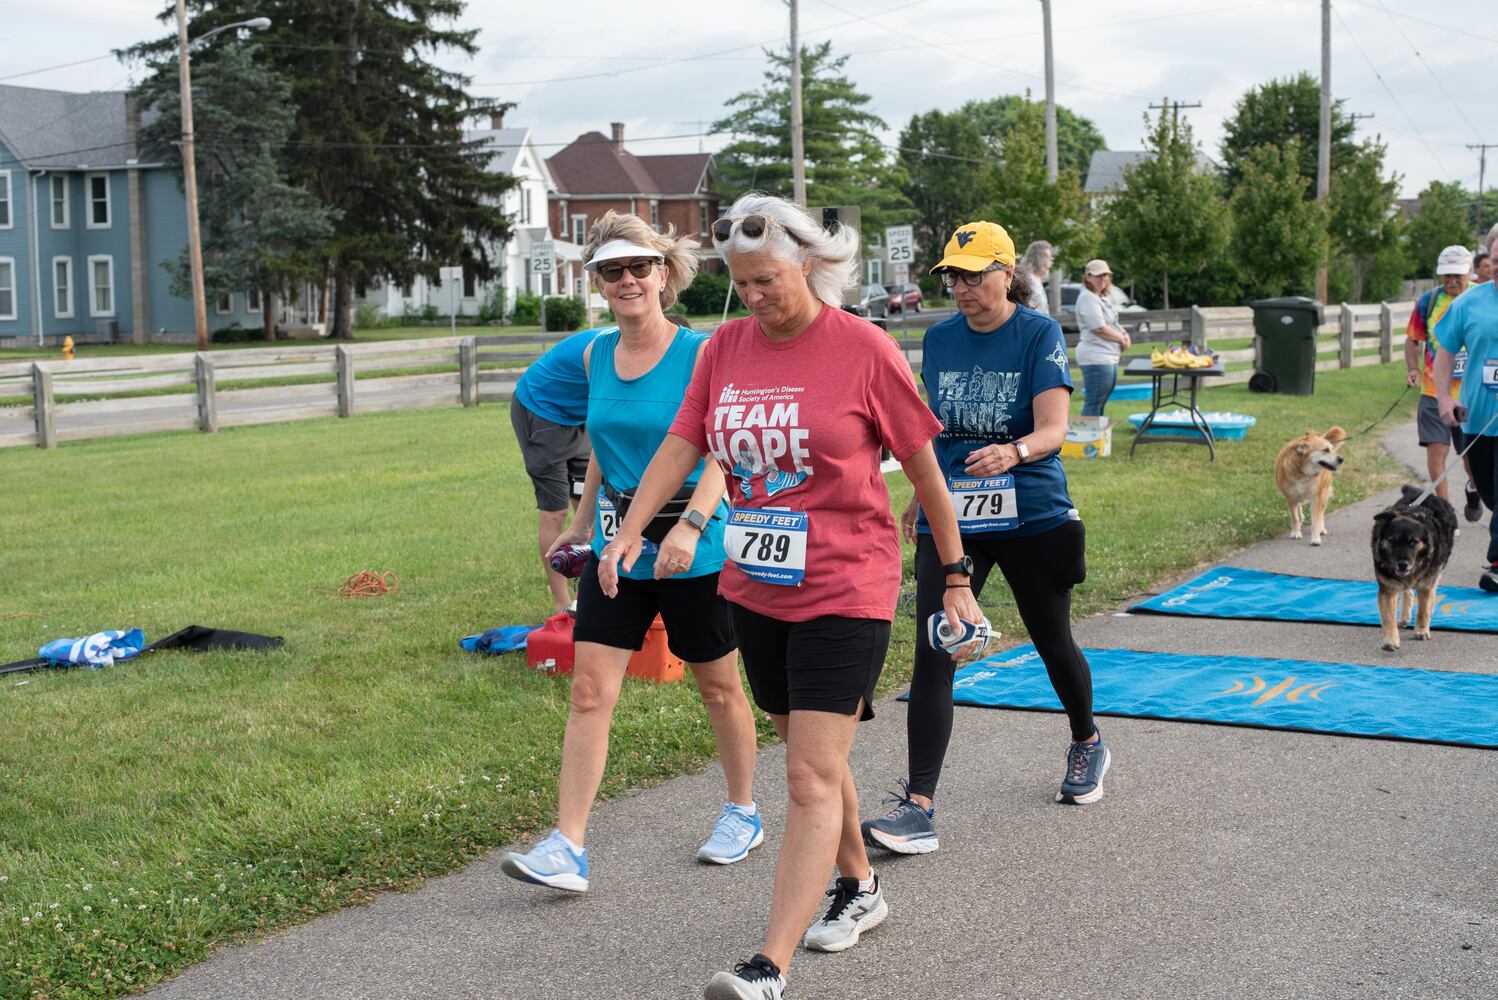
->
[598,195,984,1000]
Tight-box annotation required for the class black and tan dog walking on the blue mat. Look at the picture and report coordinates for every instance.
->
[1372,487,1456,651]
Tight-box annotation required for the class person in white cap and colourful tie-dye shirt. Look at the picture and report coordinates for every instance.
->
[1405,246,1483,521]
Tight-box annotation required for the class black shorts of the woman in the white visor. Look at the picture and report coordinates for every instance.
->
[572,555,737,663]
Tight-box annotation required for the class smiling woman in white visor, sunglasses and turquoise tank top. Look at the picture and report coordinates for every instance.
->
[500,211,764,892]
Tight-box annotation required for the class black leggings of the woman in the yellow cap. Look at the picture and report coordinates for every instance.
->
[905,521,1094,798]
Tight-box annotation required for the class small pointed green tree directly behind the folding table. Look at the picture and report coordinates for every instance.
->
[1103,109,1230,308]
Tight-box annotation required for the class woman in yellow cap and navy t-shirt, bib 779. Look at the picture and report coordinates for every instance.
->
[863,222,1109,853]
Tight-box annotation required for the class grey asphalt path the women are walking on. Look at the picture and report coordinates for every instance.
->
[151,427,1498,1000]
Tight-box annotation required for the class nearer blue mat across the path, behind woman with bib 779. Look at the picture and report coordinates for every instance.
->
[953,645,1498,750]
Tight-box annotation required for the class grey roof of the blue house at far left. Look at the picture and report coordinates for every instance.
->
[0,84,129,169]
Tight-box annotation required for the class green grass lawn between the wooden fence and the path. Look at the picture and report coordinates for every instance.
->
[0,368,1414,999]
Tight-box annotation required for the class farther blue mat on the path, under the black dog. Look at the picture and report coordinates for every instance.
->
[1131,566,1498,632]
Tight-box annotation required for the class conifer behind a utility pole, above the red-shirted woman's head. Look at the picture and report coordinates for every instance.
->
[713,42,911,234]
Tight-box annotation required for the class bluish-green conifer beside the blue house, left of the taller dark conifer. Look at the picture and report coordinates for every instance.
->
[136,45,337,340]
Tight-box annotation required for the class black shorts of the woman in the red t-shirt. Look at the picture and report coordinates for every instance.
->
[728,603,890,722]
